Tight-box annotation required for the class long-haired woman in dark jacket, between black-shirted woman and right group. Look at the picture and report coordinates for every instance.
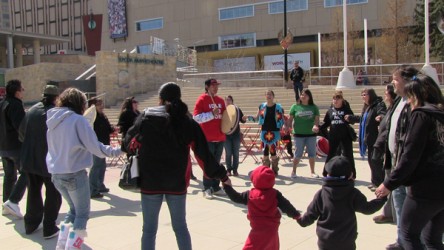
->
[345,88,387,191]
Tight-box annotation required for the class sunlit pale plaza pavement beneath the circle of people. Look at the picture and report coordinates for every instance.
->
[0,154,396,250]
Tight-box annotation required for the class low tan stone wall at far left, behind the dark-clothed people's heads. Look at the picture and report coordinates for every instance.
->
[5,63,91,104]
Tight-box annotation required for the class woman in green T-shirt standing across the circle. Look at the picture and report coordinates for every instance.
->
[286,89,319,178]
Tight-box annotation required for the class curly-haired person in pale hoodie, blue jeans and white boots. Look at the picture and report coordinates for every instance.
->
[46,88,122,249]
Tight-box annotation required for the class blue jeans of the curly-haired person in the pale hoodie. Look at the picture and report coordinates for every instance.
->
[52,170,91,230]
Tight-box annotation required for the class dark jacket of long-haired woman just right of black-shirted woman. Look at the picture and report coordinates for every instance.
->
[349,96,387,146]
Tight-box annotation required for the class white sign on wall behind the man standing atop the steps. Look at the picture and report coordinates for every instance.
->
[264,52,311,70]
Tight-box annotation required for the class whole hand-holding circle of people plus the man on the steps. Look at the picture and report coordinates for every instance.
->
[0,63,444,249]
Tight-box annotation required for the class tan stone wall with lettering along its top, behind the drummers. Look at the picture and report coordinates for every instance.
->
[96,51,176,106]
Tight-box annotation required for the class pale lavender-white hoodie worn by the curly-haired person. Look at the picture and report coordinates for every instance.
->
[46,107,121,174]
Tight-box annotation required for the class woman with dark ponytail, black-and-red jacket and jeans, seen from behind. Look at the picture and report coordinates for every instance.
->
[125,82,230,250]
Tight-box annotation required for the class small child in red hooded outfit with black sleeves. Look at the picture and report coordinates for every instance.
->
[224,166,301,250]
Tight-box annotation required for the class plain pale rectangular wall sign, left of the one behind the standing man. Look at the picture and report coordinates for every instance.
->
[214,56,256,72]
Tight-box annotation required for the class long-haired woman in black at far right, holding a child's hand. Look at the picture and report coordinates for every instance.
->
[376,73,444,250]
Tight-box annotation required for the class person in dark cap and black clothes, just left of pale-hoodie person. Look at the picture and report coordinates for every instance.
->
[19,85,62,239]
